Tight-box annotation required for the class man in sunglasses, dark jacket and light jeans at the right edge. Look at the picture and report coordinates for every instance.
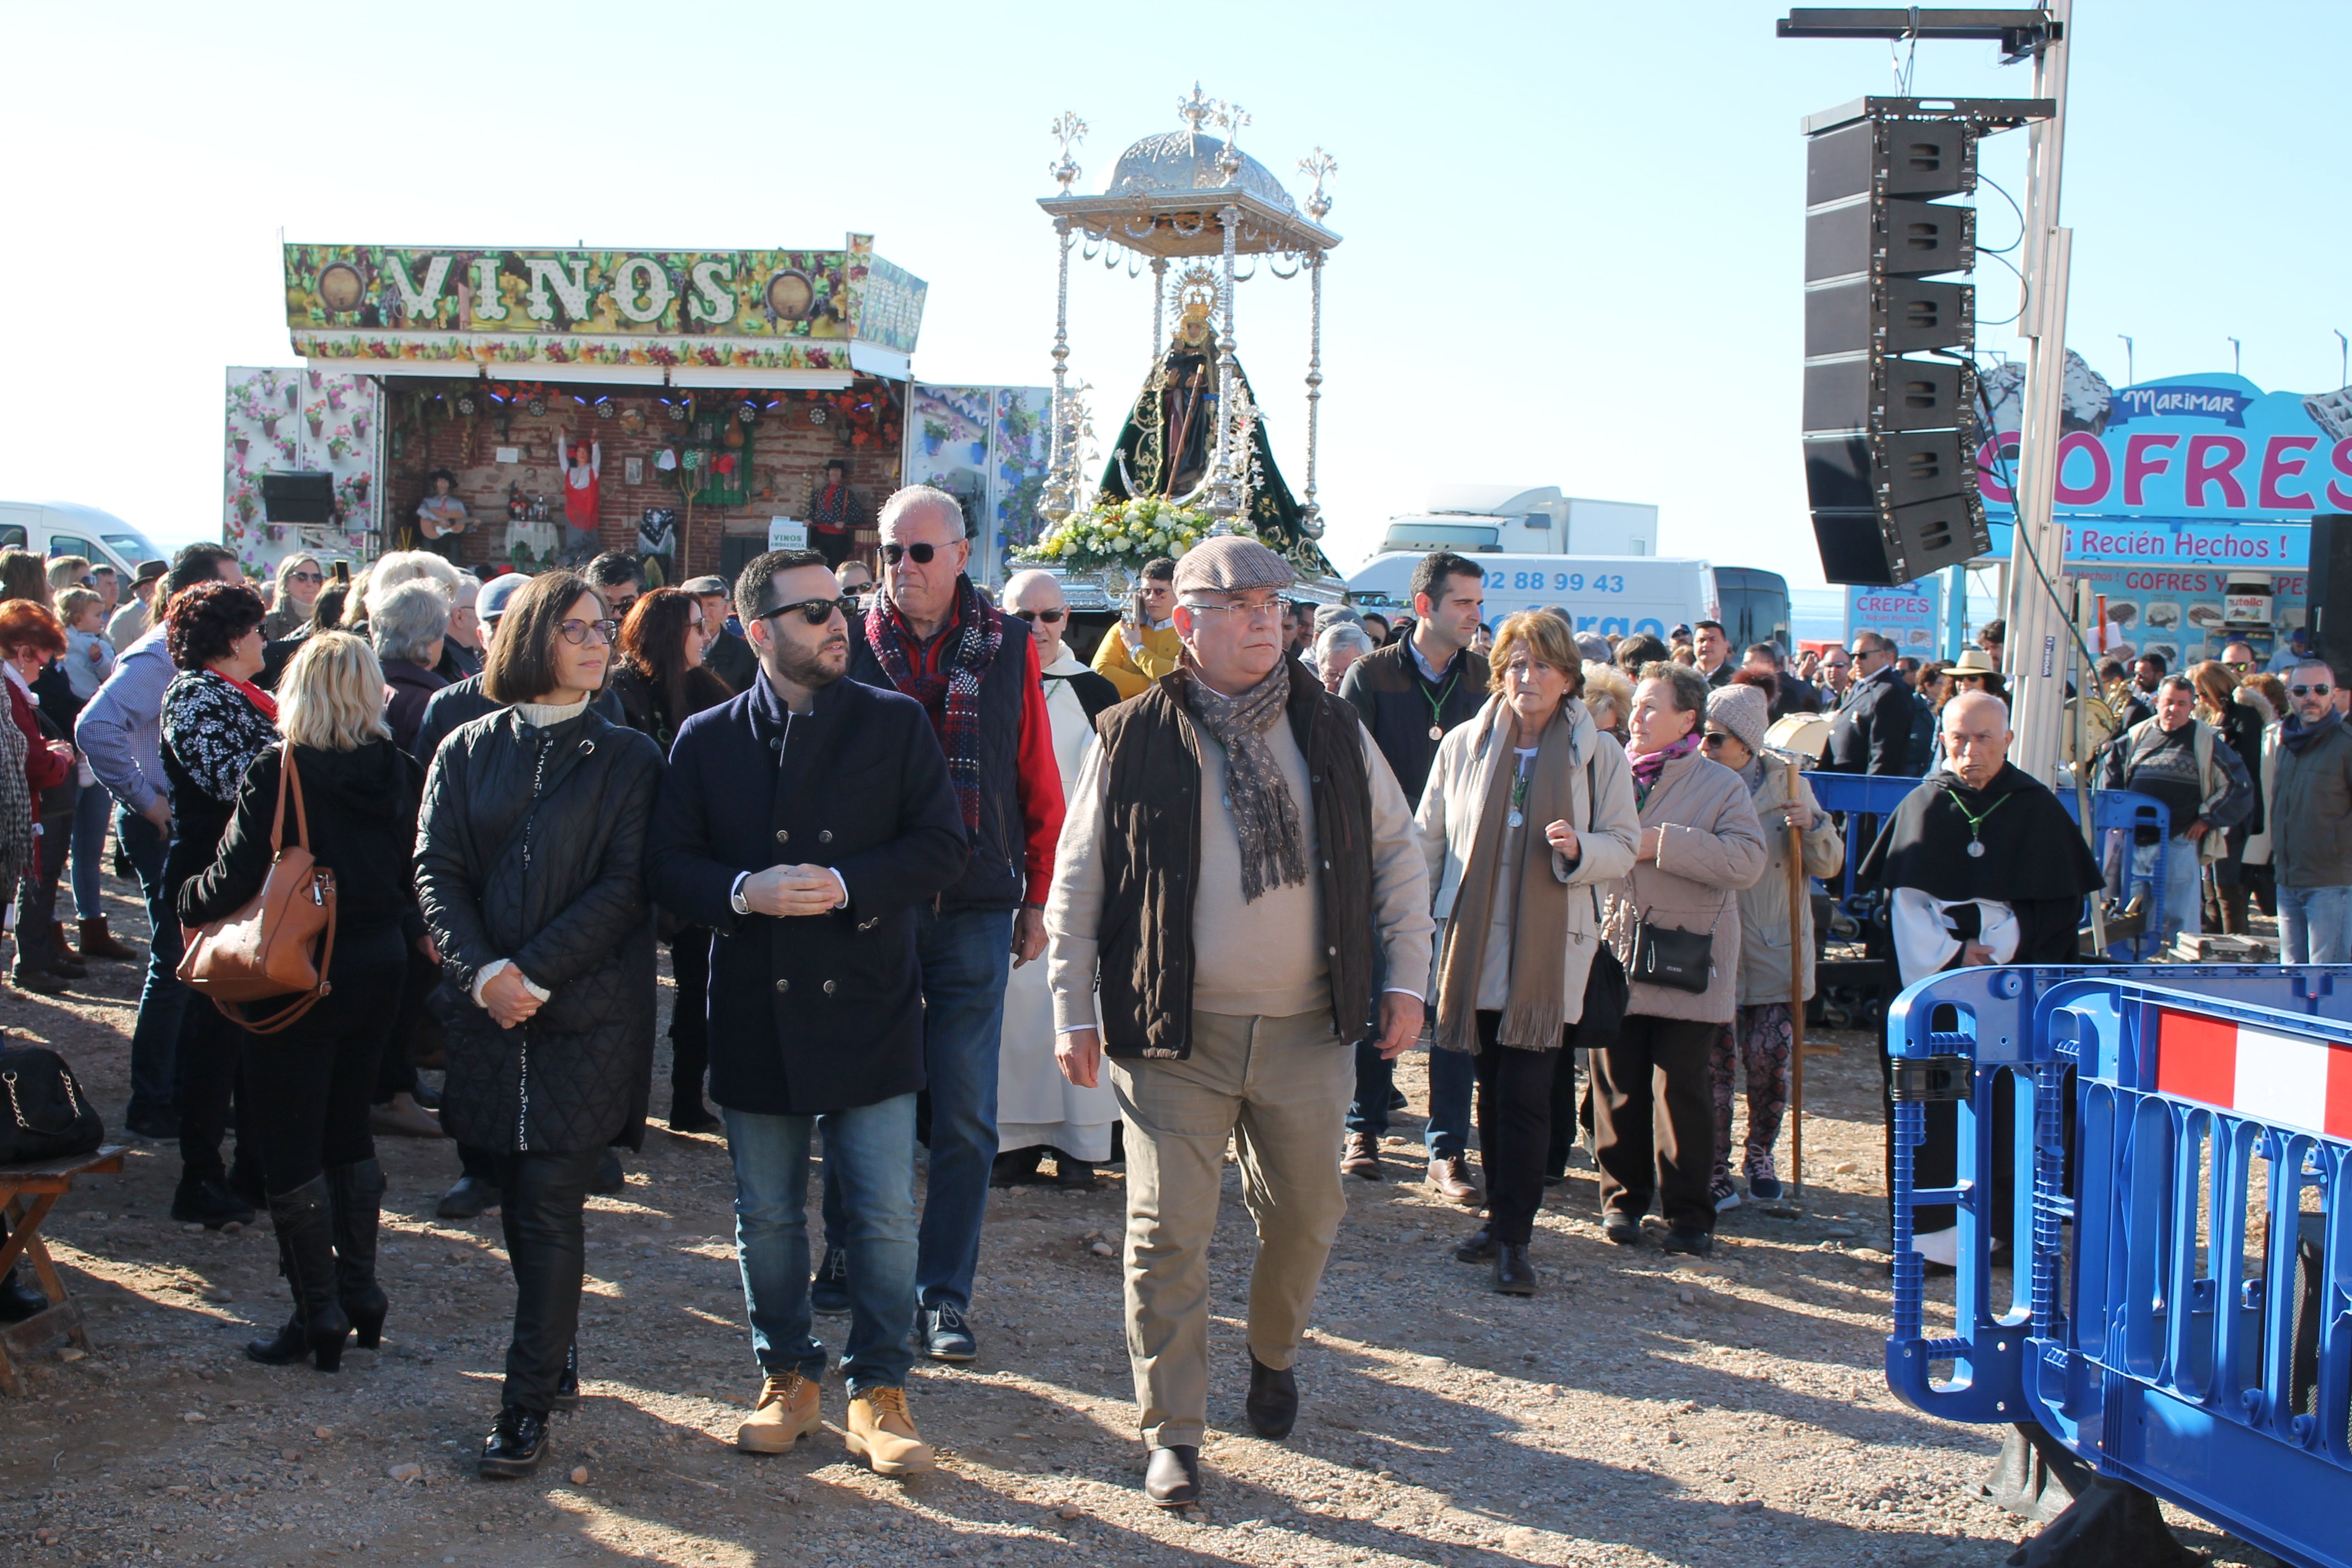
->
[2263,658,2352,964]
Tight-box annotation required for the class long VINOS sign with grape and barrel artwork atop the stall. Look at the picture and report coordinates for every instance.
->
[285,235,927,369]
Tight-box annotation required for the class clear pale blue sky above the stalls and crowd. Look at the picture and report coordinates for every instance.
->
[0,0,2352,583]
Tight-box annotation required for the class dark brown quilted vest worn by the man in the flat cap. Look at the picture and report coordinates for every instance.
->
[1096,661,1378,1060]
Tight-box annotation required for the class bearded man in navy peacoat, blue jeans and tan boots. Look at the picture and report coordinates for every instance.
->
[647,550,969,1474]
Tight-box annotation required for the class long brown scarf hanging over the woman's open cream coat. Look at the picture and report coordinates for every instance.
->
[1437,696,1576,1051]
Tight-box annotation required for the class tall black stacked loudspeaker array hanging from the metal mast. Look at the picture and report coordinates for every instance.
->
[1804,99,1992,585]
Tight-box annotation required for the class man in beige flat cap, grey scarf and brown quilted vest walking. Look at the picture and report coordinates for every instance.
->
[1047,536,1433,1507]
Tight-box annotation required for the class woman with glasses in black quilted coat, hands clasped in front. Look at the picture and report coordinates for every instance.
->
[416,571,663,1476]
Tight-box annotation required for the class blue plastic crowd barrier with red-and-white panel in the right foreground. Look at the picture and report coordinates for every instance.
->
[1886,964,2352,1568]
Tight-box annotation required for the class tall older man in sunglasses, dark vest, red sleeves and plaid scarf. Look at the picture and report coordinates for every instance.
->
[816,484,1061,1361]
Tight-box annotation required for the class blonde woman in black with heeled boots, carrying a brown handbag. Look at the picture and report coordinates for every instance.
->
[179,633,433,1373]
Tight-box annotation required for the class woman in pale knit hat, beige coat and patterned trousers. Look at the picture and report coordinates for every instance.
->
[1703,677,1847,1213]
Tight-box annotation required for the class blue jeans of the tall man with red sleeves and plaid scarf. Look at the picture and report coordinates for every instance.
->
[825,910,1014,1326]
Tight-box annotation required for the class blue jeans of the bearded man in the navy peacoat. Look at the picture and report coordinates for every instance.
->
[720,1096,917,1392]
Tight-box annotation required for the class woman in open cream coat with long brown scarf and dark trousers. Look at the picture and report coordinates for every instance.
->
[1413,611,1642,1295]
